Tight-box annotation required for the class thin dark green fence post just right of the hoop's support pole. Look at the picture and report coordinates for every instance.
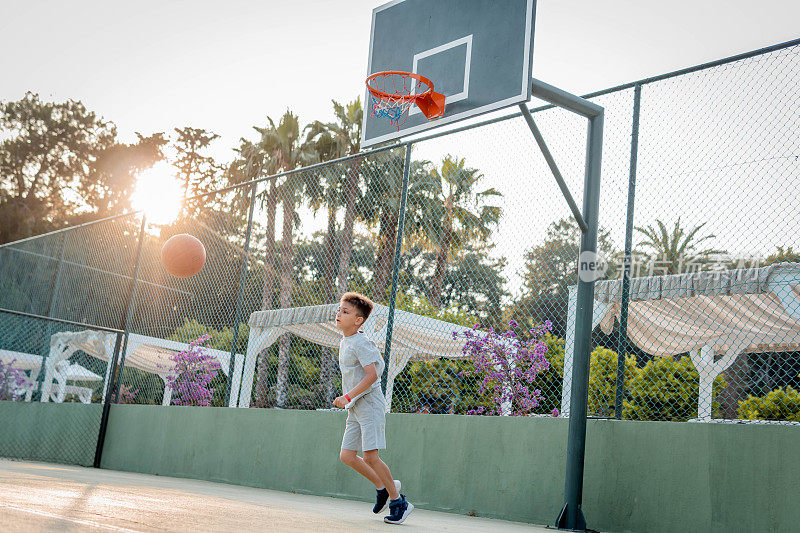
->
[614,85,642,419]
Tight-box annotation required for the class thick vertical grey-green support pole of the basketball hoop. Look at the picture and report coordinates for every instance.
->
[556,108,603,531]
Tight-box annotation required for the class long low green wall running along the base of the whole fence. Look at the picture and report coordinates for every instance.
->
[0,402,800,532]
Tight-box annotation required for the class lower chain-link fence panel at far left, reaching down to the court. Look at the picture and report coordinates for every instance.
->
[0,310,123,466]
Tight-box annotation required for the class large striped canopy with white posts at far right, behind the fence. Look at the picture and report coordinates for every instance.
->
[561,263,800,420]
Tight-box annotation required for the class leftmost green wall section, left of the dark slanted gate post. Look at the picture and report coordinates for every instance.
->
[0,402,103,466]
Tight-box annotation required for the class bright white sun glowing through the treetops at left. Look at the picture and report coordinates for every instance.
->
[131,162,183,224]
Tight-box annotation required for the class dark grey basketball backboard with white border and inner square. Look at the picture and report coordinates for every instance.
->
[361,0,536,148]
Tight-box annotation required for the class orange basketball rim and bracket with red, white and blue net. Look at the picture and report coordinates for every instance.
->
[367,70,444,130]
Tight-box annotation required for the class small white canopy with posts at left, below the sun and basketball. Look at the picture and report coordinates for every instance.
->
[42,330,242,406]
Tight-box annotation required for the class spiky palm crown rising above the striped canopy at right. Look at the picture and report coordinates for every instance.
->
[634,217,726,274]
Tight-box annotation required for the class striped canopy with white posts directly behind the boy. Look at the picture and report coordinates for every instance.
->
[239,303,470,407]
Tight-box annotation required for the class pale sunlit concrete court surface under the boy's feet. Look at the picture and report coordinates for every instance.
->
[0,459,556,533]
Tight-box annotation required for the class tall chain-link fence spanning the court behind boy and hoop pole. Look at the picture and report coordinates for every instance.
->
[0,38,800,423]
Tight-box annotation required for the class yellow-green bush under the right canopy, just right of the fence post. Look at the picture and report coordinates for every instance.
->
[623,357,725,421]
